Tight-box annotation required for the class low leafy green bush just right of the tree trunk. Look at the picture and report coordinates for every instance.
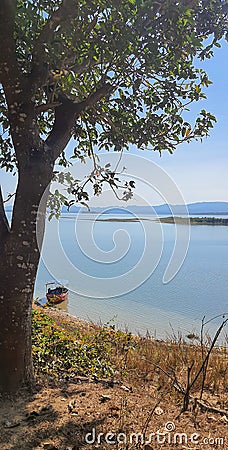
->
[32,310,114,379]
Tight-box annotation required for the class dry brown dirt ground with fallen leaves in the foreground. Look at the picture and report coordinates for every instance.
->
[0,312,228,450]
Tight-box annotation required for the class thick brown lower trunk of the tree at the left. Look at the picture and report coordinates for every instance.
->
[0,156,53,392]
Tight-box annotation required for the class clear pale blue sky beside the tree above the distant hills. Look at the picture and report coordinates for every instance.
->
[0,42,228,205]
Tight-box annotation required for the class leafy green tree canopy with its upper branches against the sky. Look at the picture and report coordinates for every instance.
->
[0,0,226,186]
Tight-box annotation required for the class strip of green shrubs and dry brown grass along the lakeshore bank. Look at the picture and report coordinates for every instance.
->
[33,309,228,394]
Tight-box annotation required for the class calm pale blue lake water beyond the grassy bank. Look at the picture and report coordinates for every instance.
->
[35,214,228,338]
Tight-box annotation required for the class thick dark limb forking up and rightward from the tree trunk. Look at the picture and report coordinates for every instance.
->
[46,84,112,161]
